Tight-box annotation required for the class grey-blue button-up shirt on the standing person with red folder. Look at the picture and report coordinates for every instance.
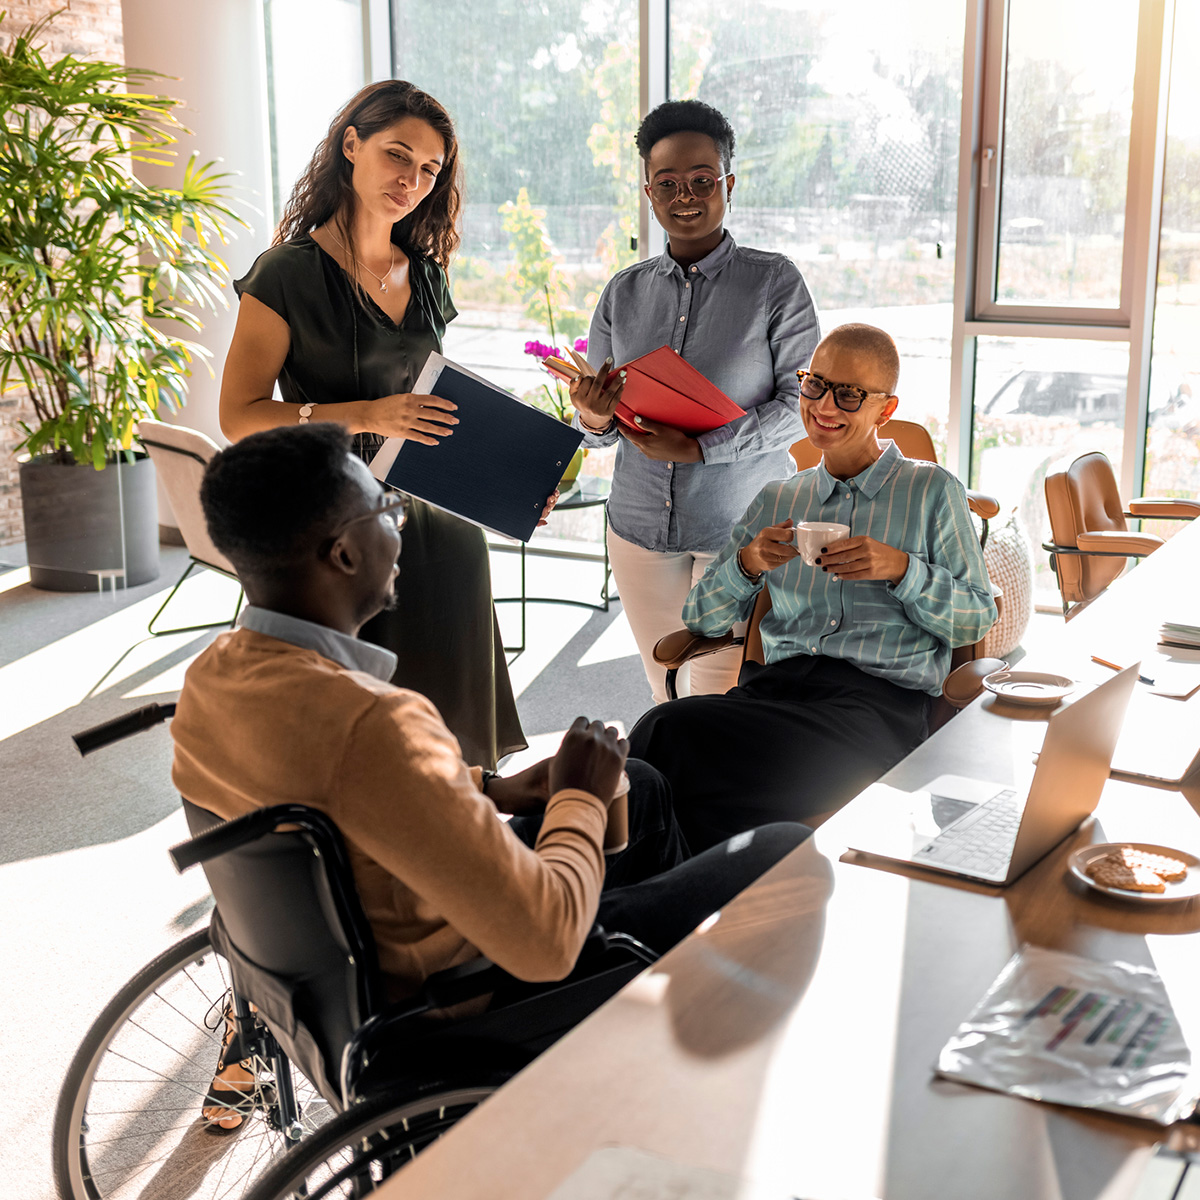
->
[576,233,821,553]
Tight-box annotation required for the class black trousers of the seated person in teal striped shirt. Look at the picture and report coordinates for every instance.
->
[629,655,930,851]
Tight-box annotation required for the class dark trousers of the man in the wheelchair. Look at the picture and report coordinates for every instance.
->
[509,758,811,954]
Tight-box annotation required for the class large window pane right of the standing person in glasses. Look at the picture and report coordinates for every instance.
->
[670,0,964,456]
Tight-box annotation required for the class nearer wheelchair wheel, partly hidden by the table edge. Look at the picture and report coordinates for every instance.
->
[236,1069,516,1200]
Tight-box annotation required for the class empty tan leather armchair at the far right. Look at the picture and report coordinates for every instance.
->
[1042,450,1200,620]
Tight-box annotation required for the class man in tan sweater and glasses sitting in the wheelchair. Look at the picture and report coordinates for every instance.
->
[172,424,809,1129]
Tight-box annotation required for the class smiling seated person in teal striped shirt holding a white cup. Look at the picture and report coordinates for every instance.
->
[630,324,996,850]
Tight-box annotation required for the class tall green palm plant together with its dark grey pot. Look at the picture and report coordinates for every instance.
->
[0,11,245,590]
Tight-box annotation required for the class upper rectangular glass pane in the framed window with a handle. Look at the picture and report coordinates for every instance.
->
[995,0,1138,308]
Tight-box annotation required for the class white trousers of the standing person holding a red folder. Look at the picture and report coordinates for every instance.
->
[608,527,746,704]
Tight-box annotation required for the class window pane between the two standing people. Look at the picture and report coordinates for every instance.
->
[391,0,638,424]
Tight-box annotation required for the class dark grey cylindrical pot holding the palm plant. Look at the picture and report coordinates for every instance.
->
[20,455,158,592]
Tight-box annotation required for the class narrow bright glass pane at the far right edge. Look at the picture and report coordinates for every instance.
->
[1144,4,1200,538]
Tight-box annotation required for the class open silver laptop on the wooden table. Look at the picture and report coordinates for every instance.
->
[850,664,1140,887]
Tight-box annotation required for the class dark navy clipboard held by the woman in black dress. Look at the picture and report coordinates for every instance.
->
[371,353,583,541]
